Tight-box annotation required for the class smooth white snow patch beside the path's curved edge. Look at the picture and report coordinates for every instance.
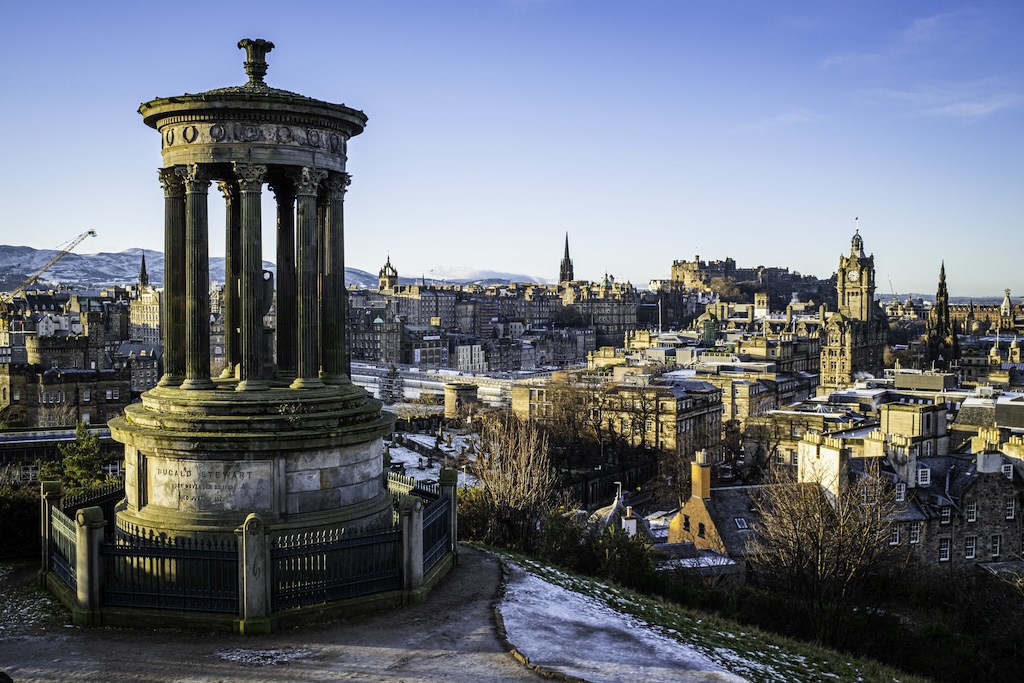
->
[499,564,746,683]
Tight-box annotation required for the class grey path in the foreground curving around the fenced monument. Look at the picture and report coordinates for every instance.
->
[0,547,543,683]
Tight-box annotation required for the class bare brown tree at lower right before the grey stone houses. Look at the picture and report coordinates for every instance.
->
[748,459,908,645]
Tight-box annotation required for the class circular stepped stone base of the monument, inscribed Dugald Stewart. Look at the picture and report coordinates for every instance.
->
[110,381,394,536]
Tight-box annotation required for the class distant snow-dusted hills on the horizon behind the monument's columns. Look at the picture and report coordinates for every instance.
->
[0,245,538,292]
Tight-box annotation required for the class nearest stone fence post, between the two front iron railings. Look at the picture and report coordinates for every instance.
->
[234,512,272,634]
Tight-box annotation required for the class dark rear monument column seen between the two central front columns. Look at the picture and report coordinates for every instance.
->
[270,179,298,377]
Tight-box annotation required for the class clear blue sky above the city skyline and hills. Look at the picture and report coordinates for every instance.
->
[0,0,1024,296]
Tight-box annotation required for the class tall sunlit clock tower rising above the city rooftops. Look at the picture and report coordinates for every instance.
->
[818,230,888,395]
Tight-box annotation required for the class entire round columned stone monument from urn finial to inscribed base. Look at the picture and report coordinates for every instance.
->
[111,39,392,537]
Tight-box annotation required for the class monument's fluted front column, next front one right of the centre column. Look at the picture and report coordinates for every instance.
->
[292,167,327,389]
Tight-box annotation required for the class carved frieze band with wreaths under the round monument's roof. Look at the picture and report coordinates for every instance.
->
[163,122,347,157]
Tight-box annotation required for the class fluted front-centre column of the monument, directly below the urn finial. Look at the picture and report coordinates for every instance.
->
[232,162,270,391]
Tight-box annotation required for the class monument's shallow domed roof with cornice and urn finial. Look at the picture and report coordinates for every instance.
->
[138,38,367,135]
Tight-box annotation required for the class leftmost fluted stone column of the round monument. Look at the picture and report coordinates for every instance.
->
[160,168,185,387]
